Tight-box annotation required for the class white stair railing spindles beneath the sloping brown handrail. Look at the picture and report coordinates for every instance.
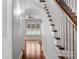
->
[53,0,77,59]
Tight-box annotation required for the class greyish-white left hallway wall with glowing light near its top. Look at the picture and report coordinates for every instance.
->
[12,0,23,59]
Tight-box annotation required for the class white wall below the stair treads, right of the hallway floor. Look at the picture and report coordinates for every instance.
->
[42,15,58,59]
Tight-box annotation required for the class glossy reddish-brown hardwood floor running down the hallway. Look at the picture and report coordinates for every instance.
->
[21,41,45,59]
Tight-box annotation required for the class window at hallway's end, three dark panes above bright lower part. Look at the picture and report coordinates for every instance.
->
[26,24,41,35]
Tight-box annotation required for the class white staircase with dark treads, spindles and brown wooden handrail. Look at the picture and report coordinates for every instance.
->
[39,0,77,59]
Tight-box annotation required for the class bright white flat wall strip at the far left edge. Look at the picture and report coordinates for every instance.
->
[2,0,12,59]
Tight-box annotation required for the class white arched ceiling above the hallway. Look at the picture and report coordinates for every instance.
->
[19,0,43,17]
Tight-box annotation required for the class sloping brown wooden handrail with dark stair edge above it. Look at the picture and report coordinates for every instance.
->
[55,0,77,29]
